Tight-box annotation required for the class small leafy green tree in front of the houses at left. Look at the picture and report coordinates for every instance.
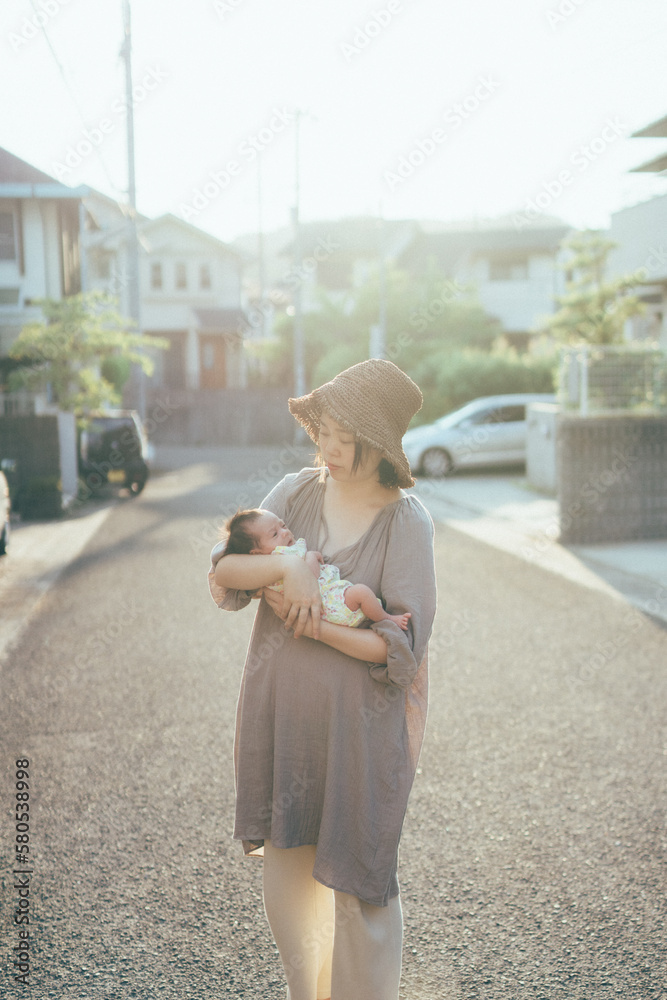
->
[8,292,169,418]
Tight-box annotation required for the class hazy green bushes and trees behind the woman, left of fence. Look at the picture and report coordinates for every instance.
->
[248,270,557,426]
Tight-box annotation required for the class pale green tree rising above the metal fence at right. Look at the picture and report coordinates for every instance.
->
[540,230,644,344]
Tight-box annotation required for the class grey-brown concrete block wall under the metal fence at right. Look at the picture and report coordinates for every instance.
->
[557,415,667,544]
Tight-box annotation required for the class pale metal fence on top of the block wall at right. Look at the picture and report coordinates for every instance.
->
[558,344,667,416]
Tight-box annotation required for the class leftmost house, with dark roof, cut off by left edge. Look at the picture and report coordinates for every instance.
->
[0,149,89,408]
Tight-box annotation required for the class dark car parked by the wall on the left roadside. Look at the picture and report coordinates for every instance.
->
[79,410,149,494]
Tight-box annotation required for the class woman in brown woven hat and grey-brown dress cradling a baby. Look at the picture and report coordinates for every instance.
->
[209,359,435,1000]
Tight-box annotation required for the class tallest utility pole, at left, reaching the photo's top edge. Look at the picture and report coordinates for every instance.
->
[121,0,146,420]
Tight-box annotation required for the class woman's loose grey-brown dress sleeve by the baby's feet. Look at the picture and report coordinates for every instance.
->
[369,496,436,688]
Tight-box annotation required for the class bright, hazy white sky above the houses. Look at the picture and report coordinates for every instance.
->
[0,0,667,241]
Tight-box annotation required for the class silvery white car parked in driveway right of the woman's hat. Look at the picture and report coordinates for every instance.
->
[403,393,556,477]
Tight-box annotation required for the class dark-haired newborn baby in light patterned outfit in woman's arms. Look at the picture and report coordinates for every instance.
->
[224,508,411,630]
